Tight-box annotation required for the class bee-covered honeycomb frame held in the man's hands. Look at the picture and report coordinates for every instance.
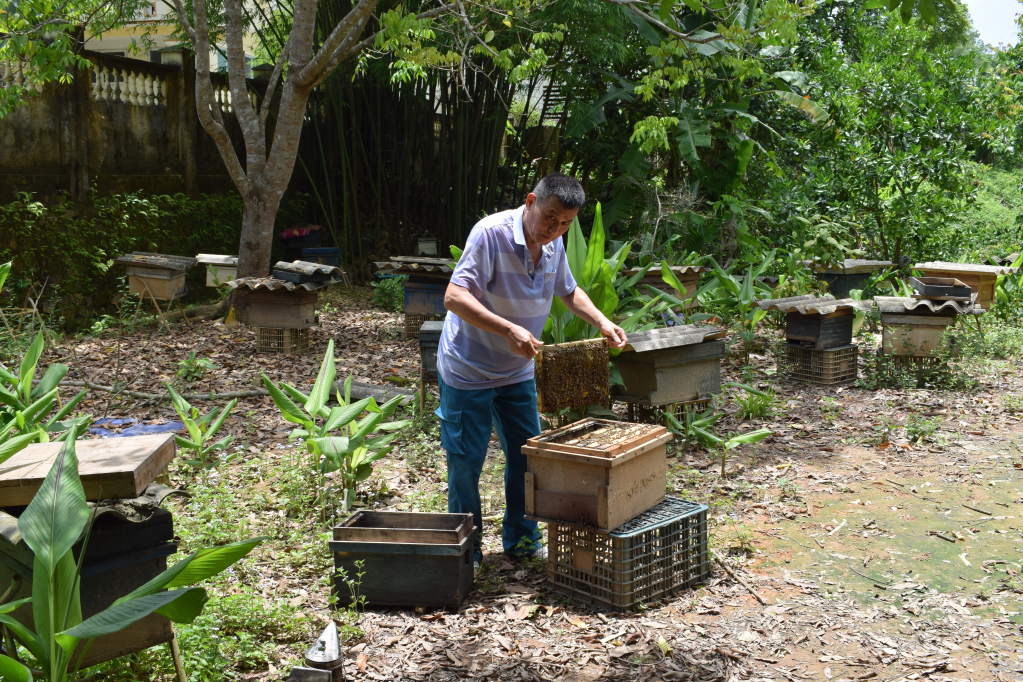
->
[536,338,611,414]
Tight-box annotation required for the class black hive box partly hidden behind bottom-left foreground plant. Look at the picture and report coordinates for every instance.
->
[0,507,177,668]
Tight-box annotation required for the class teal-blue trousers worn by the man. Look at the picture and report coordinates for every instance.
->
[436,377,543,561]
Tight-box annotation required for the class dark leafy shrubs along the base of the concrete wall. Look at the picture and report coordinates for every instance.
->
[0,191,241,328]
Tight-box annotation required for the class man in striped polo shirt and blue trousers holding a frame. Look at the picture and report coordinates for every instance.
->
[437,173,626,562]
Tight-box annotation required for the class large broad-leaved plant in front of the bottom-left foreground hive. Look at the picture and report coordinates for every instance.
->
[0,436,262,682]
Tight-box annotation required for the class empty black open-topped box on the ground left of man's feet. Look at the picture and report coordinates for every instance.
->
[329,511,475,608]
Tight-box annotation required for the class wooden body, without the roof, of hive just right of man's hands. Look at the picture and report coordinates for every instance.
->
[614,340,724,406]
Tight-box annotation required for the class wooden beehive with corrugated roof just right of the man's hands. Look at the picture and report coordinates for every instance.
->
[615,325,725,406]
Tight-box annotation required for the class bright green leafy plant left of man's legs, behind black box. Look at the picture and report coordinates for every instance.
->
[263,339,409,513]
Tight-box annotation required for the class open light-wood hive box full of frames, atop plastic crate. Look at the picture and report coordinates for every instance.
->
[522,419,672,530]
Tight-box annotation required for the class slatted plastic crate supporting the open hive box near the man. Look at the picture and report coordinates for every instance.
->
[547,497,710,610]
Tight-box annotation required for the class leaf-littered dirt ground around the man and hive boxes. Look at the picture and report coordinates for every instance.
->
[44,291,1023,682]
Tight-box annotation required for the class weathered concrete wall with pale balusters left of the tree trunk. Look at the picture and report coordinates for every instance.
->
[0,52,240,202]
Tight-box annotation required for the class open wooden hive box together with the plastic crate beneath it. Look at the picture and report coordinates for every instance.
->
[523,418,709,609]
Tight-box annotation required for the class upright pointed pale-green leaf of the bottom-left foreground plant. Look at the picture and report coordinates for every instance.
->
[17,440,89,588]
